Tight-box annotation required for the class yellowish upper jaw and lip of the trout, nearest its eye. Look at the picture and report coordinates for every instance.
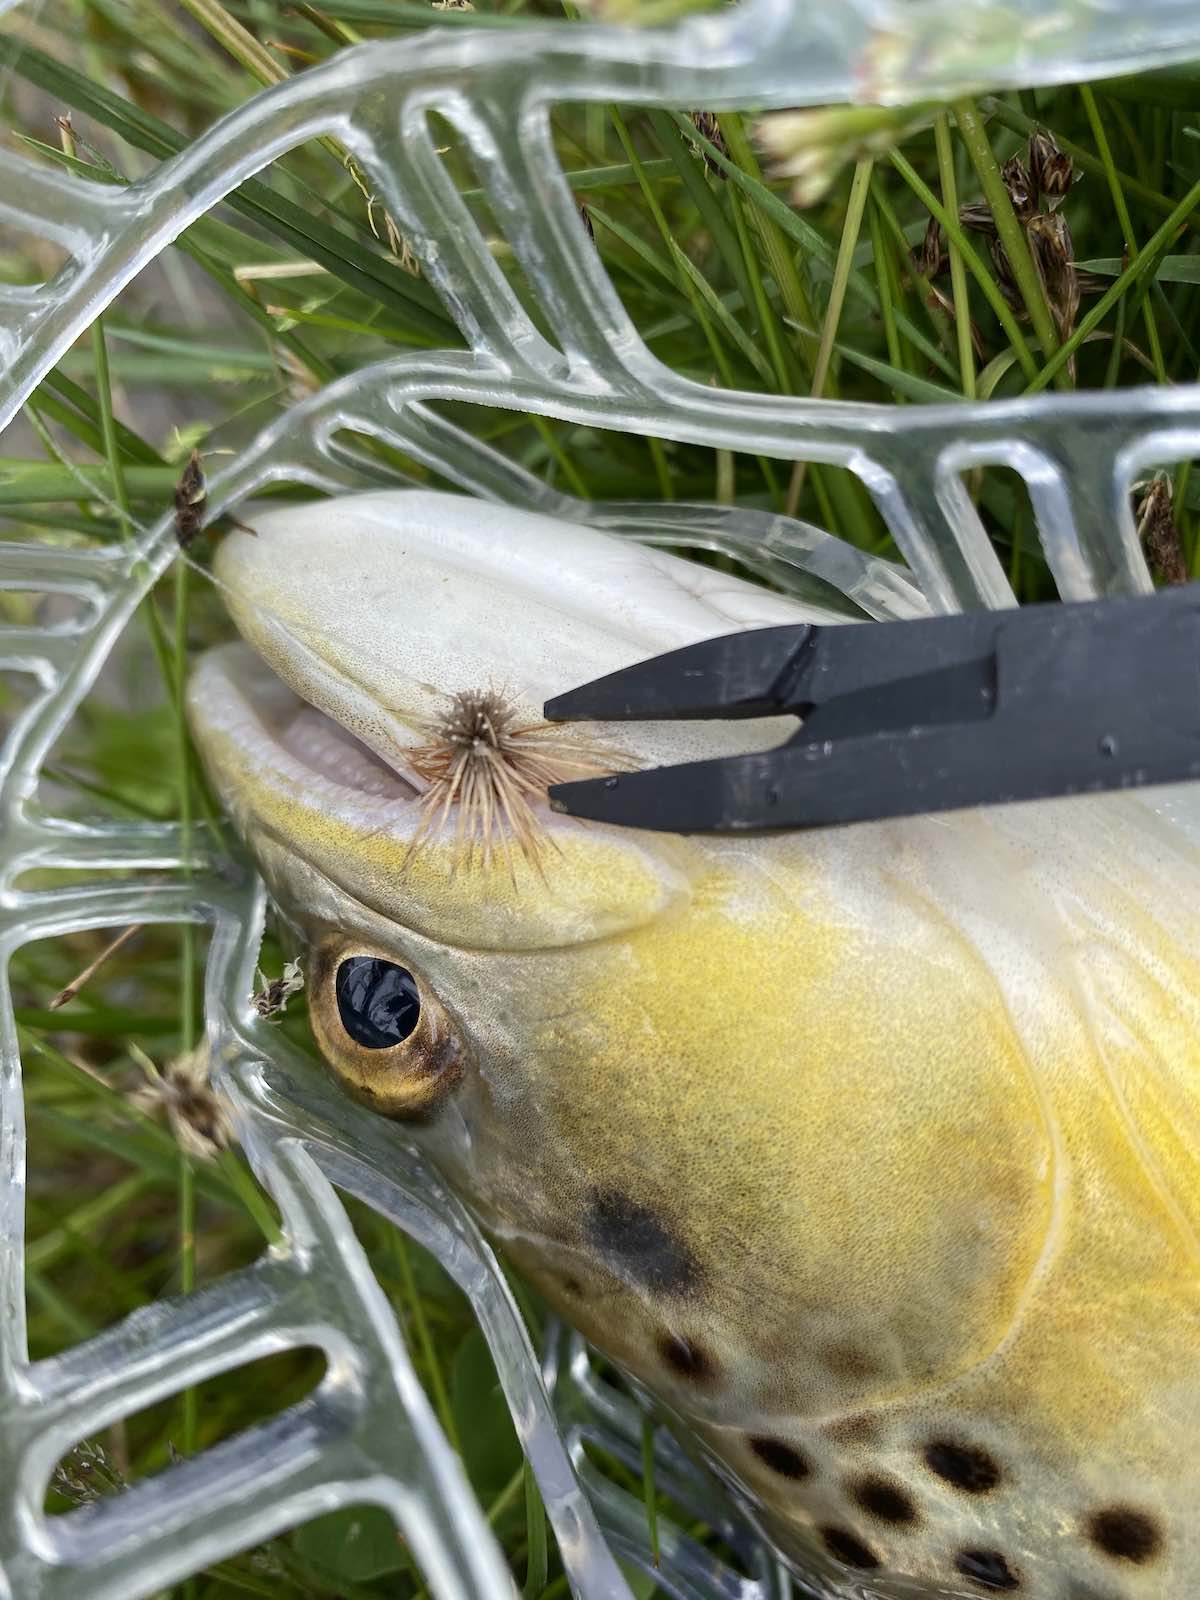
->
[187,640,693,954]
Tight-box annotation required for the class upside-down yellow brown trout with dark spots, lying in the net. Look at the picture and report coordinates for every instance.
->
[189,491,1200,1600]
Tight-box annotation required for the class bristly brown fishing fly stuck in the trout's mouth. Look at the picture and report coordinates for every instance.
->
[405,688,629,882]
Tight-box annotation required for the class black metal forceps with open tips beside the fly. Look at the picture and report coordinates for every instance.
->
[546,582,1200,834]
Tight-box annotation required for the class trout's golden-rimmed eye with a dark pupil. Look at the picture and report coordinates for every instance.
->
[307,933,470,1118]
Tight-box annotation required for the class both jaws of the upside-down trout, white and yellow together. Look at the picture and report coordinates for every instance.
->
[189,491,838,949]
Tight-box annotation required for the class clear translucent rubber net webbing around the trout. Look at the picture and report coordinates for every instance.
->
[0,0,1200,1600]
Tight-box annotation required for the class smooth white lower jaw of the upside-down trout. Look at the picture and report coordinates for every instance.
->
[214,490,819,784]
